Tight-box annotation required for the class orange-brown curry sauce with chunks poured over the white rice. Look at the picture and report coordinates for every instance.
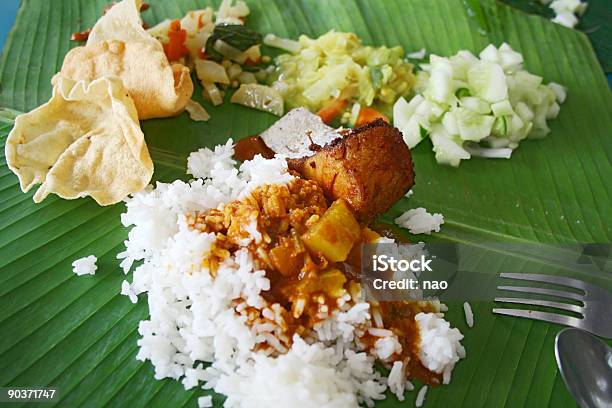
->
[188,142,442,385]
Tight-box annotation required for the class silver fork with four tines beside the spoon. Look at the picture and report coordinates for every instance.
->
[493,273,612,339]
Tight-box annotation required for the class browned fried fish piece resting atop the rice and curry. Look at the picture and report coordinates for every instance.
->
[288,119,414,223]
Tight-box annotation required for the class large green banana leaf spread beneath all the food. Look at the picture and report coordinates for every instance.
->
[0,0,612,407]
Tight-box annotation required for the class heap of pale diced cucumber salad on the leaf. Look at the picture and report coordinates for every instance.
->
[393,43,566,167]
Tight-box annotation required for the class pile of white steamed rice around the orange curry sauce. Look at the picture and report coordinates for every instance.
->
[118,140,465,407]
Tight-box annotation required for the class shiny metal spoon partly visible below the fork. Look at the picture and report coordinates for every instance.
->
[555,328,612,408]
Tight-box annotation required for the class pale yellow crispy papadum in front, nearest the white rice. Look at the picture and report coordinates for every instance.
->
[5,77,153,205]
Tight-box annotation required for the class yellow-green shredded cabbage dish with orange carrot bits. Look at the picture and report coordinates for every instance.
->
[265,31,414,126]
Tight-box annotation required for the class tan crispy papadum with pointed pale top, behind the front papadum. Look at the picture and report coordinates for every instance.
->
[52,0,193,119]
